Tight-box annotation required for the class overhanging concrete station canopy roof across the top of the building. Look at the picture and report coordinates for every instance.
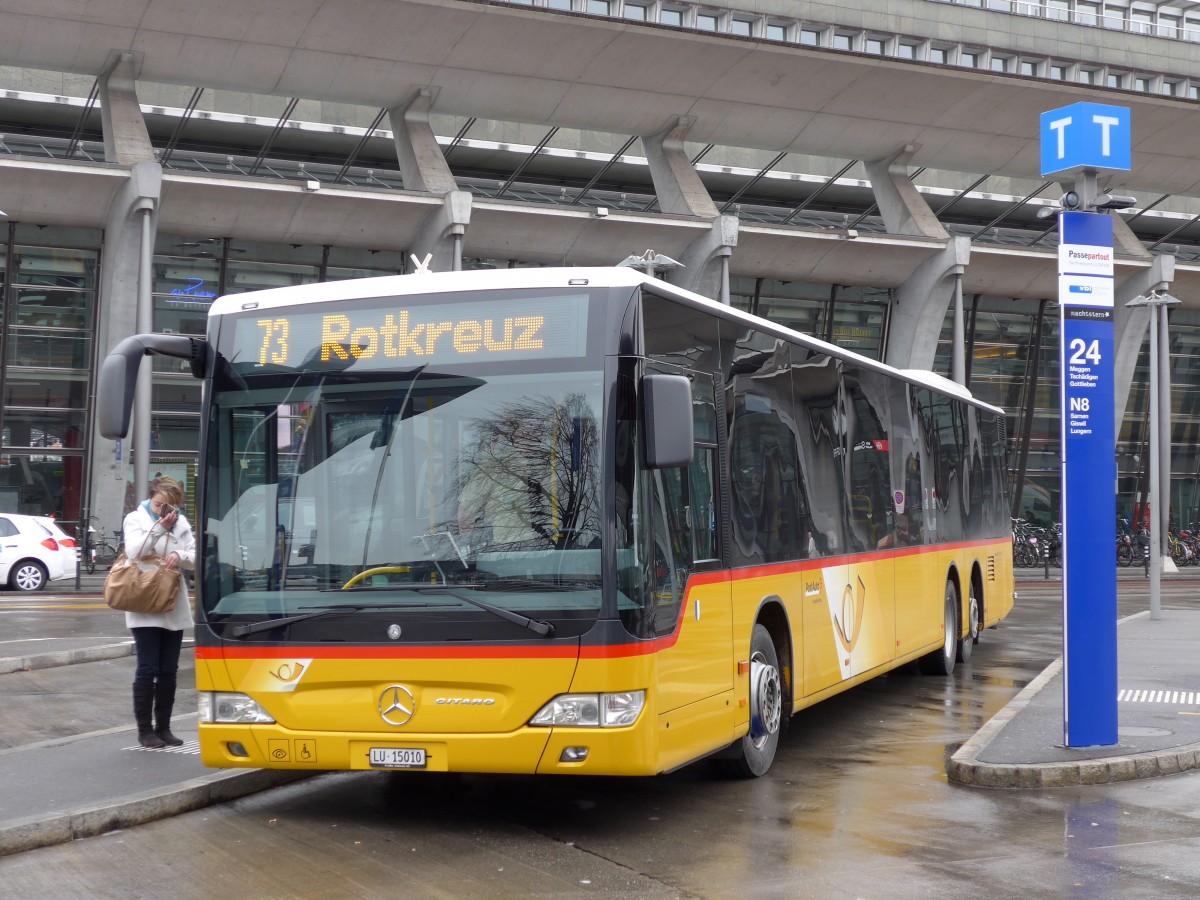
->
[0,0,1200,285]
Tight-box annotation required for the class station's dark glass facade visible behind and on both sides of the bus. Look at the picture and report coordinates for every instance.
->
[0,223,1200,542]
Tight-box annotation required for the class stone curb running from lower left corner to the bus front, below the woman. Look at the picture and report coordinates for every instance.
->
[0,769,323,857]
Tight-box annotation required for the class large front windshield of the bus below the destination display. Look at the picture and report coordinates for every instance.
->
[203,292,601,640]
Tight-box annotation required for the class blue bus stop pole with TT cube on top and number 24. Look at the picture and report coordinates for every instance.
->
[1040,103,1135,748]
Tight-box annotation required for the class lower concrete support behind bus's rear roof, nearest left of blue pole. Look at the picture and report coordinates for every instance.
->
[883,236,971,372]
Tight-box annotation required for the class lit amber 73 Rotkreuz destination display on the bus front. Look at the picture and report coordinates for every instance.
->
[222,294,588,371]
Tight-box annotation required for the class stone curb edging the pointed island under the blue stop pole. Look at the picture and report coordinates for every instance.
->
[946,659,1200,788]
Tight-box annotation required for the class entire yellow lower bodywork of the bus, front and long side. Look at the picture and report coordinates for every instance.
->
[196,540,1014,775]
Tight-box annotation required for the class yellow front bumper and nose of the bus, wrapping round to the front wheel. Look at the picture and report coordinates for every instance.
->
[196,642,736,775]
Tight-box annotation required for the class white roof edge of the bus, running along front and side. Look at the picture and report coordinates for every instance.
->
[209,265,1004,415]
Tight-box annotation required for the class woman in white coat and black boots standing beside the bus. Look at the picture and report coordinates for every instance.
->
[124,476,196,749]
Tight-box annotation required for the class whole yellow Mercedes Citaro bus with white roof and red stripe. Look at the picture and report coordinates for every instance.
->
[98,268,1013,776]
